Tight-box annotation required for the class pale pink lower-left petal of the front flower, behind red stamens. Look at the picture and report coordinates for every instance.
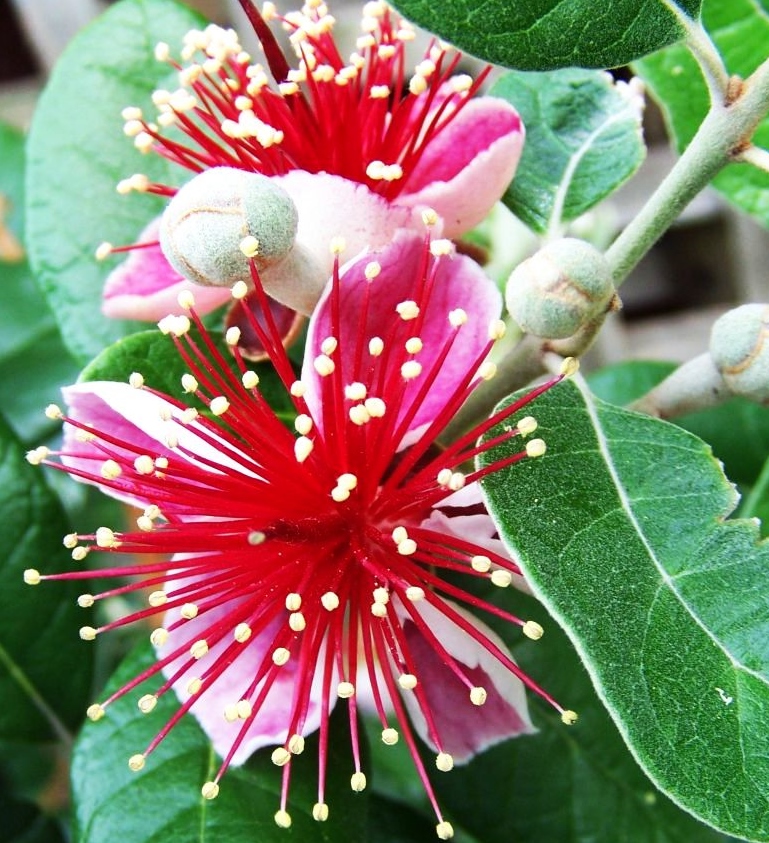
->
[156,592,335,765]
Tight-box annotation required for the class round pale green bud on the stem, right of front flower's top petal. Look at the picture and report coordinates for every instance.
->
[505,238,614,339]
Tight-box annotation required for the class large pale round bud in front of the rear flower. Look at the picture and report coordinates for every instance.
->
[160,167,298,287]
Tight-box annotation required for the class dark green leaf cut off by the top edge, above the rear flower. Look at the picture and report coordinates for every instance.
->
[395,0,701,70]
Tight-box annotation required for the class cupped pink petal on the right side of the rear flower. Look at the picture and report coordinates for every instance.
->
[398,97,524,238]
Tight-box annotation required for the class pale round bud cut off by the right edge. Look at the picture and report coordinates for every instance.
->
[710,304,769,401]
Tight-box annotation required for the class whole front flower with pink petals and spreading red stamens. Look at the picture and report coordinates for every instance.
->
[25,231,574,839]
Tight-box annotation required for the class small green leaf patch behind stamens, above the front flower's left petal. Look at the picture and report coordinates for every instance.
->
[80,331,296,424]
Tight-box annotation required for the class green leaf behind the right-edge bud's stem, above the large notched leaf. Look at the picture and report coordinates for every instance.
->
[587,360,769,488]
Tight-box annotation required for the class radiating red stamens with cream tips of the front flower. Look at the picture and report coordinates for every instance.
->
[25,226,576,839]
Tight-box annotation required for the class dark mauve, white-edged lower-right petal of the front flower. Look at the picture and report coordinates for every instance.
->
[401,600,536,763]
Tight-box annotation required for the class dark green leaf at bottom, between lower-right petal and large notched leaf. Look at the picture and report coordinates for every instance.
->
[435,589,733,843]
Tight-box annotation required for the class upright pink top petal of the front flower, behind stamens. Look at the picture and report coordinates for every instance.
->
[302,231,501,442]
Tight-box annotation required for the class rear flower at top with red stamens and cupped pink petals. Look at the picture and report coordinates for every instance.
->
[101,0,523,328]
